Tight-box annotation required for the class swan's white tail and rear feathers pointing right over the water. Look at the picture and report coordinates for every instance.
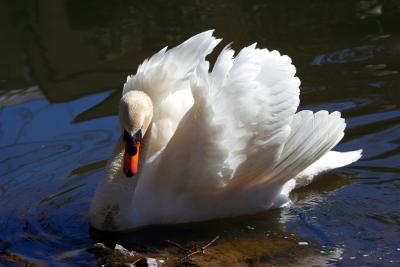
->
[260,110,362,187]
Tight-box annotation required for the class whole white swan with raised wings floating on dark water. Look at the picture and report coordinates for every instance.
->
[90,30,362,231]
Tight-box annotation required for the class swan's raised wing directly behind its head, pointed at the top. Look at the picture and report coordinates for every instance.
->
[123,31,220,157]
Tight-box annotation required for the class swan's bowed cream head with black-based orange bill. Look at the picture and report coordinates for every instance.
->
[119,90,153,177]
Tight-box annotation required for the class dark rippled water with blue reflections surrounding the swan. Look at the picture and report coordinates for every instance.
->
[0,0,400,266]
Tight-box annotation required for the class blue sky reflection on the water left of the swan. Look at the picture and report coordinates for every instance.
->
[0,92,118,264]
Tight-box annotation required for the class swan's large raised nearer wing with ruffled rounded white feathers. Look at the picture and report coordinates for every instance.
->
[155,45,300,195]
